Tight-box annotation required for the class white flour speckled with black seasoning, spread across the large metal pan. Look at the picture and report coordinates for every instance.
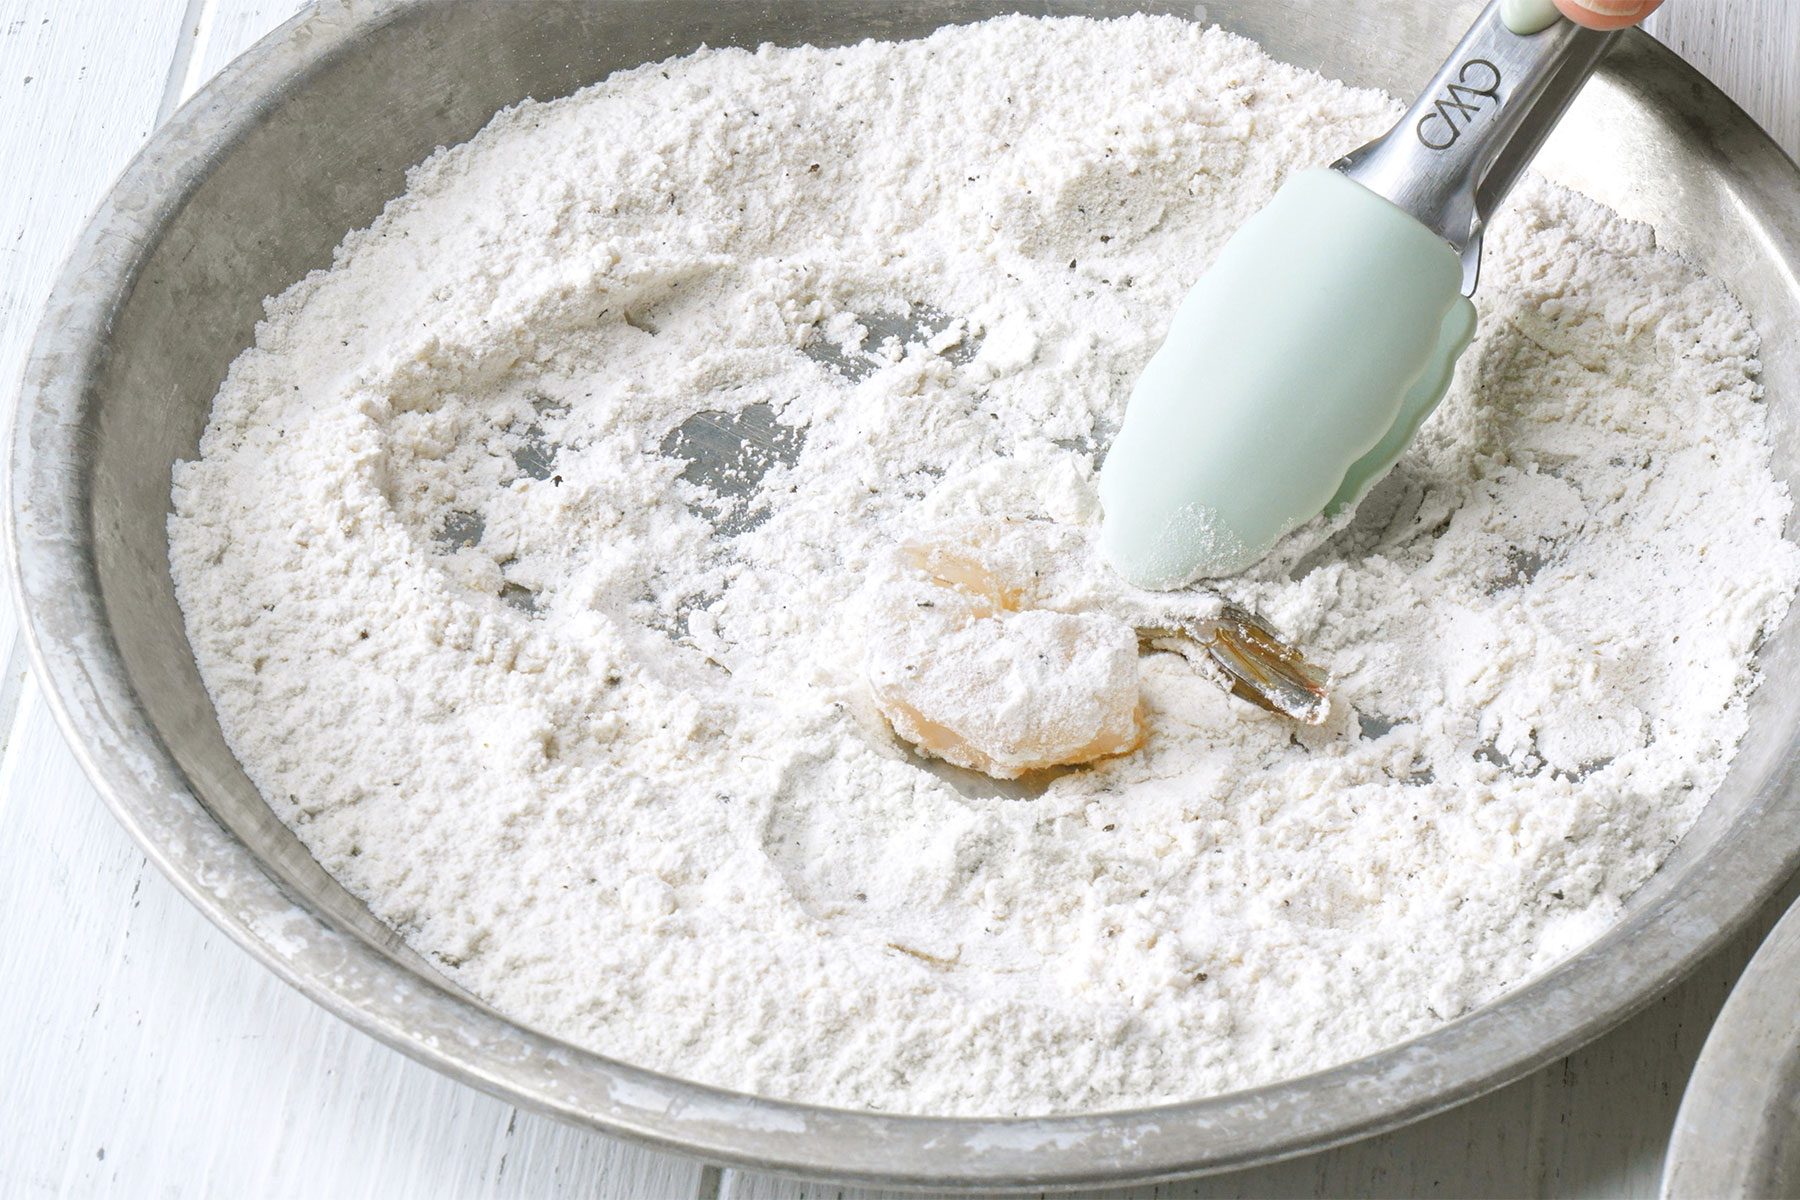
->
[171,18,1800,1114]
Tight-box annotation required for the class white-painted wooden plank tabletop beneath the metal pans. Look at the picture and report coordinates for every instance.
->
[0,0,1800,1200]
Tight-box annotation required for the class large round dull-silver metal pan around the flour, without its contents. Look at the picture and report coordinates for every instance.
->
[7,0,1800,1187]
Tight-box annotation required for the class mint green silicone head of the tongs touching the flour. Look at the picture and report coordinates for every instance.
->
[1100,171,1474,588]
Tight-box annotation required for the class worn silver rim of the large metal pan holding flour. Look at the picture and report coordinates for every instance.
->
[10,0,1800,1191]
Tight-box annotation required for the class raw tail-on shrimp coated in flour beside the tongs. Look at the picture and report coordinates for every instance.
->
[864,520,1328,779]
